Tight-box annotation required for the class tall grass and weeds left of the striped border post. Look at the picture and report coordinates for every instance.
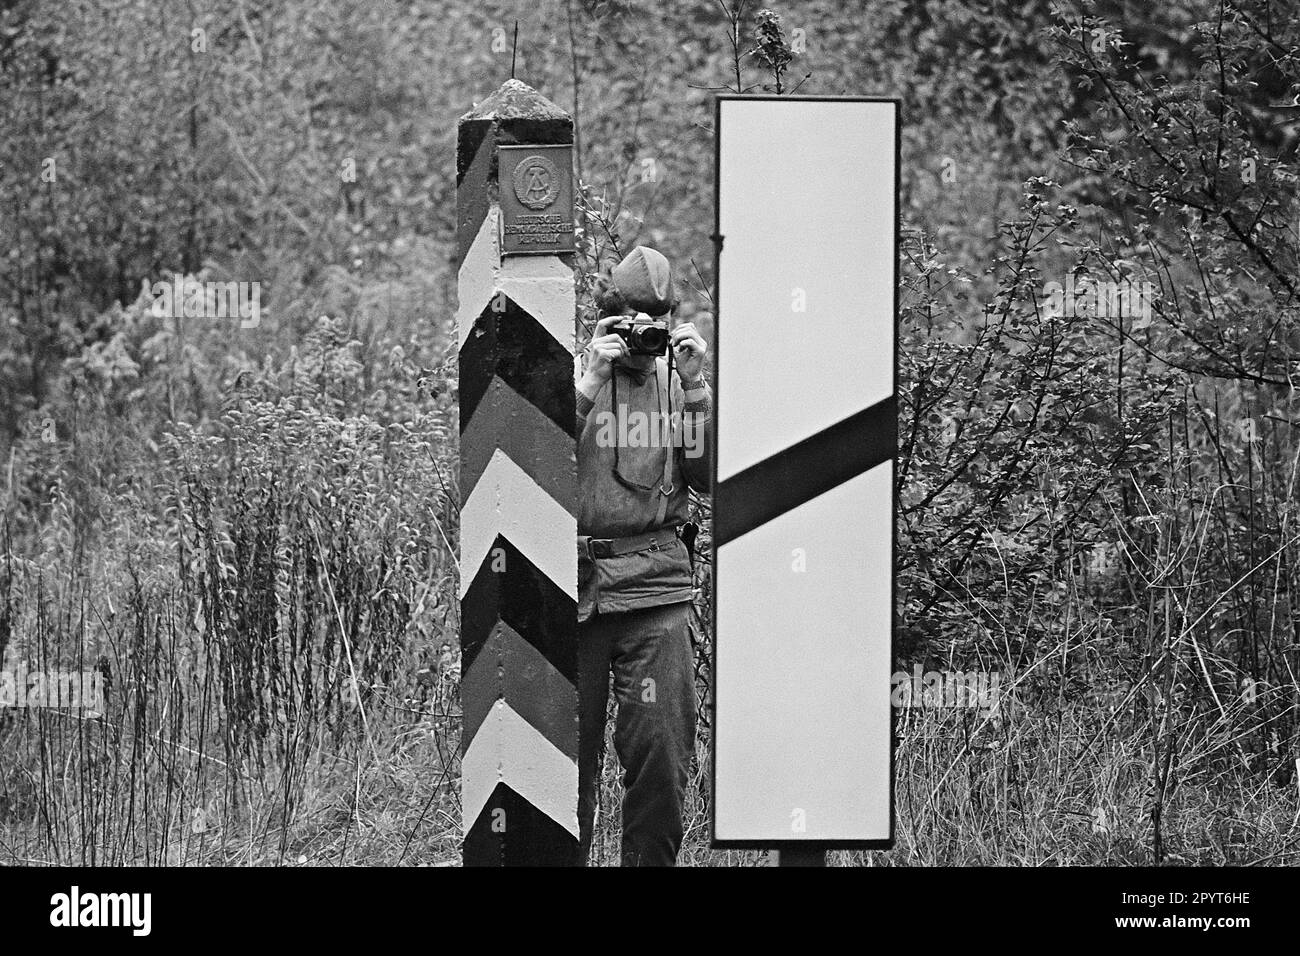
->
[0,317,459,865]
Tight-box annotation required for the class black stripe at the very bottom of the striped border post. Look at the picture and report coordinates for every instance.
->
[462,783,580,866]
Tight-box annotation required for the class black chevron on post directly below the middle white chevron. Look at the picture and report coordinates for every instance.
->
[460,535,577,683]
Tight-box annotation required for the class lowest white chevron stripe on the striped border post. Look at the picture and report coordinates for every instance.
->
[460,697,579,838]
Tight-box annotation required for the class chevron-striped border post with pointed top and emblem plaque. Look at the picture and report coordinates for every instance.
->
[456,79,579,866]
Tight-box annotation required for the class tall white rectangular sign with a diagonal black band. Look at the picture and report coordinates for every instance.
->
[712,96,898,848]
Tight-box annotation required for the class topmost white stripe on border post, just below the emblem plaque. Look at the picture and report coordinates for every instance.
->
[456,206,577,354]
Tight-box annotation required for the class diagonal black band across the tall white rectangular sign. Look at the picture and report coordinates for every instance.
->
[714,395,898,545]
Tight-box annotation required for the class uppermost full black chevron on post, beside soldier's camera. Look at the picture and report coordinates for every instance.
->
[460,293,576,438]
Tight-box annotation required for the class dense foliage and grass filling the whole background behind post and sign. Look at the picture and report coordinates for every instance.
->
[0,0,1300,864]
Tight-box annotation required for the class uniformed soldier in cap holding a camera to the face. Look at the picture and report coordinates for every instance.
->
[577,246,712,866]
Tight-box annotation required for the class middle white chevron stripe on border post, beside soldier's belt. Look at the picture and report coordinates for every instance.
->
[460,449,577,601]
